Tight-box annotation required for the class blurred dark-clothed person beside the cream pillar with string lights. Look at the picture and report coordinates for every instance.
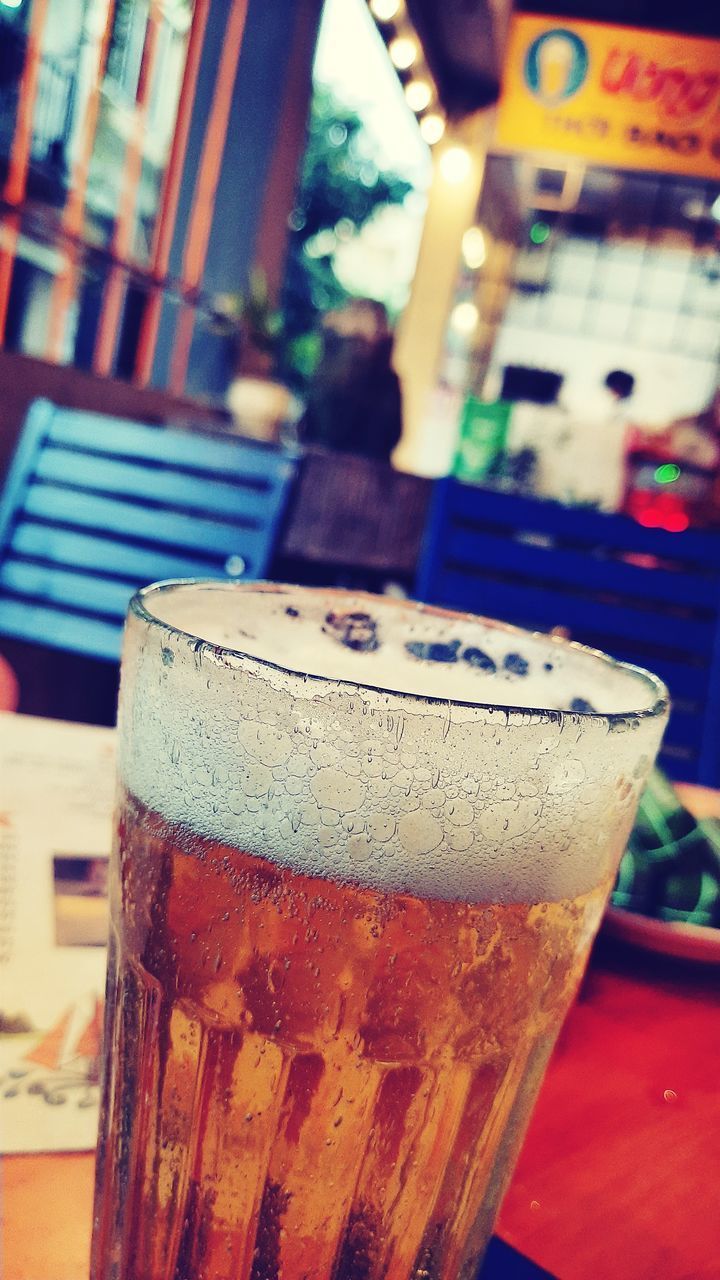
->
[299,298,402,462]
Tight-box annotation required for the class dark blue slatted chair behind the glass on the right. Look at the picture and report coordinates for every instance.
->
[416,479,720,786]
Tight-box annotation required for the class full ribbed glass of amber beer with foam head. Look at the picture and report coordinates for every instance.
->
[92,582,667,1280]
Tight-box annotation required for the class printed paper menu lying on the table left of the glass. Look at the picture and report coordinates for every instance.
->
[0,714,115,1153]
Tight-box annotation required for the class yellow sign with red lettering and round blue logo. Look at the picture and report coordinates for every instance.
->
[497,14,720,179]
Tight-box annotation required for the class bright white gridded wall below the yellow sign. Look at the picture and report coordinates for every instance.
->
[489,237,720,424]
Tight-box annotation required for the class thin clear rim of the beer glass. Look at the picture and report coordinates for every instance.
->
[128,577,670,726]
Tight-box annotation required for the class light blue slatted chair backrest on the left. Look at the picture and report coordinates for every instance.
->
[0,401,296,660]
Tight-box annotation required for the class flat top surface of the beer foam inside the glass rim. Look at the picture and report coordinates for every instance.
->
[152,585,657,714]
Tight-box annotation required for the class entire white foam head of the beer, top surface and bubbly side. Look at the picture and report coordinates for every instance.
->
[120,585,664,902]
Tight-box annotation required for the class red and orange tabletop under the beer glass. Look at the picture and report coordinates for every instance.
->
[0,721,720,1280]
